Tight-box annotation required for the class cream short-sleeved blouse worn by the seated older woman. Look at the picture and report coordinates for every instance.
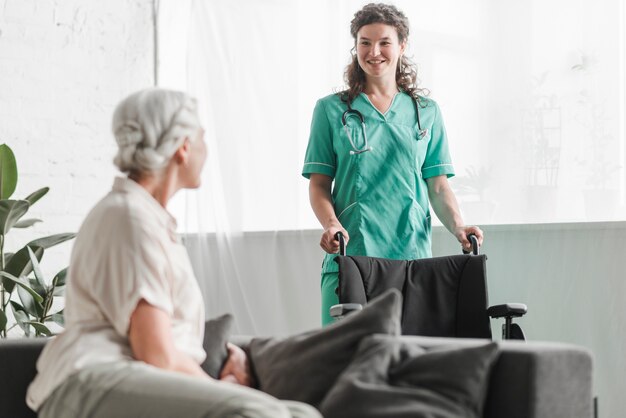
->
[26,178,206,410]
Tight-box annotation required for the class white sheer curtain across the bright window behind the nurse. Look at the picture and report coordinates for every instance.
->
[158,0,626,333]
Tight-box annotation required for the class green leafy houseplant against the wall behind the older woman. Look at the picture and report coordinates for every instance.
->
[0,144,75,338]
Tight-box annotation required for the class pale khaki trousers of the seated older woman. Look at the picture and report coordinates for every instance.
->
[38,361,322,418]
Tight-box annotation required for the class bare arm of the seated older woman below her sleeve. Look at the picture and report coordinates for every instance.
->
[128,299,210,378]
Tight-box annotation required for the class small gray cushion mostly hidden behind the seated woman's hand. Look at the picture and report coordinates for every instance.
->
[201,314,233,379]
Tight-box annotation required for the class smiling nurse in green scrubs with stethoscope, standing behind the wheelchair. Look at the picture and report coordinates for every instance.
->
[302,4,483,325]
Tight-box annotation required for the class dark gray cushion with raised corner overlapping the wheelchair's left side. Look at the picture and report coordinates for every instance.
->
[248,289,402,407]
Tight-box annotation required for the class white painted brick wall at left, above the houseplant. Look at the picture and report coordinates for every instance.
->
[0,0,154,274]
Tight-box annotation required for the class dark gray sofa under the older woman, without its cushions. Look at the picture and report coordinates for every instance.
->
[0,336,593,418]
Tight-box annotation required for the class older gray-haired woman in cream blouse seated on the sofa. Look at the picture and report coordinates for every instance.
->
[27,89,319,418]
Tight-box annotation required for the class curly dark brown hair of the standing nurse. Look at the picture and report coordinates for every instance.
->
[339,3,428,101]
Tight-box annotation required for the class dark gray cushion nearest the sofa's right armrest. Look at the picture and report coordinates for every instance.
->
[320,335,498,418]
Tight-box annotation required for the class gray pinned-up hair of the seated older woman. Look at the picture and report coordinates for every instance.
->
[113,88,200,173]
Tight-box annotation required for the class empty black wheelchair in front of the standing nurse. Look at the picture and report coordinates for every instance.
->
[330,232,528,340]
